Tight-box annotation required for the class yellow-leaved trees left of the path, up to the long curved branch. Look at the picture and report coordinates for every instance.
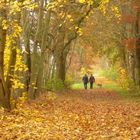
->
[0,0,104,109]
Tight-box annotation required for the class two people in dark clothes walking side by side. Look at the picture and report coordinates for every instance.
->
[82,74,95,89]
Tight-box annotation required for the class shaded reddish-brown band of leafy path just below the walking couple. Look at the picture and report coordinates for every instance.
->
[61,88,122,103]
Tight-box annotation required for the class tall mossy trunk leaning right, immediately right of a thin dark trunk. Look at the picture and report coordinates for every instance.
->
[28,0,44,99]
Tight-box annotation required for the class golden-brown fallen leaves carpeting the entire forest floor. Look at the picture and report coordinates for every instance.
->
[0,89,140,140]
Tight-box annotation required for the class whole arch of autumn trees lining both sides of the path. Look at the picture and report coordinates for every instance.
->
[0,0,140,109]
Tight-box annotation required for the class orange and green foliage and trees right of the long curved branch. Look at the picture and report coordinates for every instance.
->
[67,0,140,87]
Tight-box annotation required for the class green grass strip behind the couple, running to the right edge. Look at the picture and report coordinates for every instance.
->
[71,83,140,101]
